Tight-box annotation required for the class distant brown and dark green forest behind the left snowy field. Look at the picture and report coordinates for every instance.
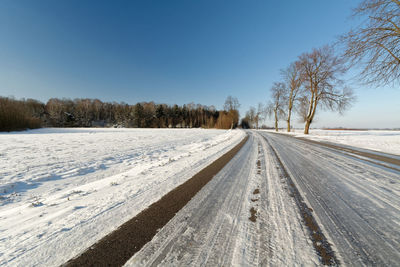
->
[0,97,239,131]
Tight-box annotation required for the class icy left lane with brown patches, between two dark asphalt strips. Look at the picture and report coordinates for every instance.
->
[126,134,320,266]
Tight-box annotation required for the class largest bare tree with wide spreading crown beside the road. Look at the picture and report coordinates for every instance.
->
[298,46,354,134]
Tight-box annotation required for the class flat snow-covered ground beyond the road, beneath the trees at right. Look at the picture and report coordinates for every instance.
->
[262,129,400,155]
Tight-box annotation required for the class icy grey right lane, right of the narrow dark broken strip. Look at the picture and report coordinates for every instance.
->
[261,132,400,266]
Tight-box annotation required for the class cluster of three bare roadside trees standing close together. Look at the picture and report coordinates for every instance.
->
[247,46,355,134]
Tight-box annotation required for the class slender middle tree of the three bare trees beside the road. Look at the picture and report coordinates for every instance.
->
[281,62,303,132]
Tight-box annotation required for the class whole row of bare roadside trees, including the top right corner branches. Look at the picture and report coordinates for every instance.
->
[242,0,400,134]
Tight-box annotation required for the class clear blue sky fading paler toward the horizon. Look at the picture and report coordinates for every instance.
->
[0,0,400,128]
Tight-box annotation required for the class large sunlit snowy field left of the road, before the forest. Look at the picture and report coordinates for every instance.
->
[0,129,245,266]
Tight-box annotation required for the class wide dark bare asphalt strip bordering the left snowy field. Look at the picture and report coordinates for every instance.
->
[63,136,248,266]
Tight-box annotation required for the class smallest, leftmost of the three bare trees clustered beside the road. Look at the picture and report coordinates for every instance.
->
[266,83,286,131]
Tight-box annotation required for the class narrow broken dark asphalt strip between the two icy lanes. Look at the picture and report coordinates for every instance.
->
[264,137,340,265]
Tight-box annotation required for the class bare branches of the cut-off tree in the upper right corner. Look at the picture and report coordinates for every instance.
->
[341,0,400,85]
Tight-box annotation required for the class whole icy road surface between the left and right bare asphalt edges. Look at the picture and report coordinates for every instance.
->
[126,131,400,266]
